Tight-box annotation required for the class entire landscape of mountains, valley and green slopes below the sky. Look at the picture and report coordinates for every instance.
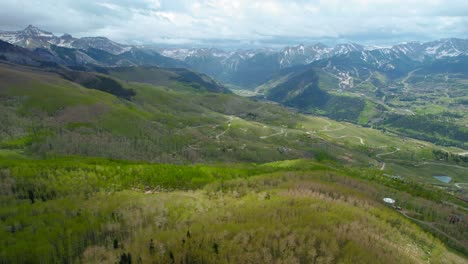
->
[0,23,468,263]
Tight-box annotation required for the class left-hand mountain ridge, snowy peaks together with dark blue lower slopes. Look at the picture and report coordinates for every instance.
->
[0,25,185,67]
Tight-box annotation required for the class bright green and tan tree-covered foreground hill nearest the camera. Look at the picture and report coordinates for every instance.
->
[0,156,467,263]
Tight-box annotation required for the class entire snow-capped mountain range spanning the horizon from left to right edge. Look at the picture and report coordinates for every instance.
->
[0,25,468,89]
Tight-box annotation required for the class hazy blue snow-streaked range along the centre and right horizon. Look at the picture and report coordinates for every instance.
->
[159,38,468,88]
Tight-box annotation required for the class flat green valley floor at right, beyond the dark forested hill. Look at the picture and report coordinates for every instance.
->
[314,69,468,148]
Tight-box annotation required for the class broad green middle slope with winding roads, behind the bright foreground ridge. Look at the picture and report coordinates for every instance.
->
[0,62,467,184]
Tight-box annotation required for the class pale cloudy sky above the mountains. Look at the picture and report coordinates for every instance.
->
[0,0,468,46]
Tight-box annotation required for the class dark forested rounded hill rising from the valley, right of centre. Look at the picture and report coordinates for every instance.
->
[256,69,382,125]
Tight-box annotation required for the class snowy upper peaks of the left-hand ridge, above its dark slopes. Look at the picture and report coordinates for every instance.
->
[0,25,132,55]
